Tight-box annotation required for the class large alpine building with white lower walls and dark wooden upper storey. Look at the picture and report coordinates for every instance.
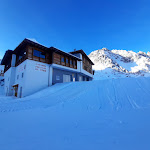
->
[2,39,93,98]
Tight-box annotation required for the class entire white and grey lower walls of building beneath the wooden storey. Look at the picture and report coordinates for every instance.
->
[5,56,93,97]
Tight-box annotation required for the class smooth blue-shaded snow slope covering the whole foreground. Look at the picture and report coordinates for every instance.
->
[0,77,150,150]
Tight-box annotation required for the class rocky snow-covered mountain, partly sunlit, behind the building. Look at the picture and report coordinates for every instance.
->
[89,48,150,79]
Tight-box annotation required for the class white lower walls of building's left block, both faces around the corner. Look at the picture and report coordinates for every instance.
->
[5,59,52,97]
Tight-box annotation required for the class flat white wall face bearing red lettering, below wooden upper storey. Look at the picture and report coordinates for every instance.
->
[23,60,50,96]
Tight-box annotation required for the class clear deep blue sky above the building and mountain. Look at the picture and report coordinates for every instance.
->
[0,0,150,58]
